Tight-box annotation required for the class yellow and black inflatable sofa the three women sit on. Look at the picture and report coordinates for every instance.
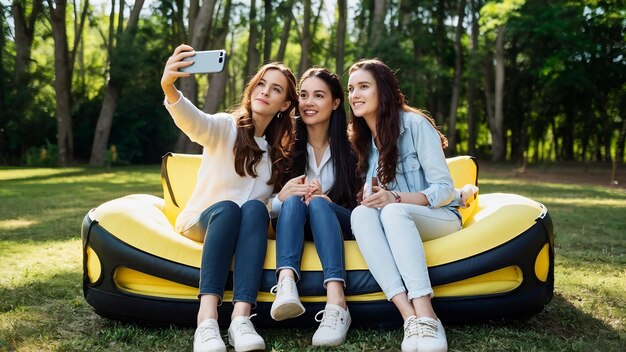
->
[82,153,554,326]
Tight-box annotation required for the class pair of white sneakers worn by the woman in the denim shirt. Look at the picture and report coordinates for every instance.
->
[402,315,448,352]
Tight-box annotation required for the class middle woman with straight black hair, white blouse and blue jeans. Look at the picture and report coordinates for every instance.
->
[270,68,360,346]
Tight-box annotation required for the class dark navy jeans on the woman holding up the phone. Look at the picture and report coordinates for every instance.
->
[186,200,269,306]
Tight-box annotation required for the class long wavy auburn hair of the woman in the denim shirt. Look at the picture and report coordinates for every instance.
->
[348,59,448,185]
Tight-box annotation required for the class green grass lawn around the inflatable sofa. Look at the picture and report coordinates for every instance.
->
[0,166,626,352]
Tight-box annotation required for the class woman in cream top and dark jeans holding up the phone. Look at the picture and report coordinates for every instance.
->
[161,45,298,351]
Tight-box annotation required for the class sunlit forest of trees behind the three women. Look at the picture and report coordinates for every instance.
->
[0,0,626,166]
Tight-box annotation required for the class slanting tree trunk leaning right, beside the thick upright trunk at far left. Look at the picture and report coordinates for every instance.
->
[89,0,144,166]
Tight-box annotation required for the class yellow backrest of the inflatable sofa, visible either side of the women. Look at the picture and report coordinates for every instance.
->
[161,153,478,224]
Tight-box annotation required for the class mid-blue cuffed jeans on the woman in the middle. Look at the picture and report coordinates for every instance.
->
[276,196,352,287]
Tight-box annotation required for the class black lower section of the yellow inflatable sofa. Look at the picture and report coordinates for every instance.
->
[81,208,554,327]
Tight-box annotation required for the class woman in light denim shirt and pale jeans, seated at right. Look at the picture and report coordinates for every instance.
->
[348,60,461,352]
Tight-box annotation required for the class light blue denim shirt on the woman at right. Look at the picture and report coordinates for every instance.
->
[366,111,460,217]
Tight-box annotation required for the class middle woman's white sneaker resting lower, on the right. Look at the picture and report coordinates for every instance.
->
[312,304,352,346]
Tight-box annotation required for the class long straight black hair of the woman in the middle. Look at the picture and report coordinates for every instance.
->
[291,67,361,209]
